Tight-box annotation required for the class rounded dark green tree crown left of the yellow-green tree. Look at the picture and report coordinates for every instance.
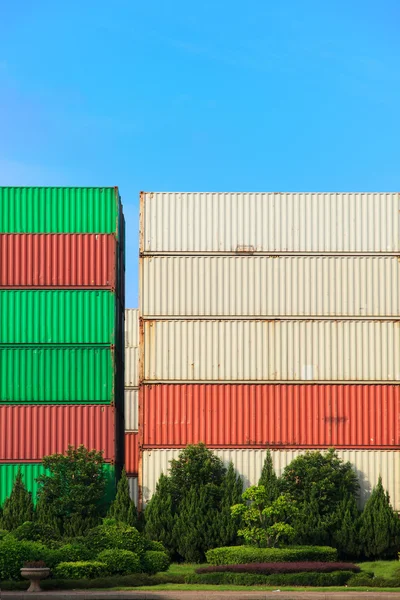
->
[169,443,226,503]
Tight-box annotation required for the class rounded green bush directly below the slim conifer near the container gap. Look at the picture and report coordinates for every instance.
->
[85,519,145,555]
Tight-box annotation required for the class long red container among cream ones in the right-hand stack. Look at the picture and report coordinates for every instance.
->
[142,384,400,450]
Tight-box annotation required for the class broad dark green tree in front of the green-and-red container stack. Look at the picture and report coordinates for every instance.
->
[38,446,106,537]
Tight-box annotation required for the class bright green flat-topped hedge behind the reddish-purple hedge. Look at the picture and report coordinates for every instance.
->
[206,546,337,565]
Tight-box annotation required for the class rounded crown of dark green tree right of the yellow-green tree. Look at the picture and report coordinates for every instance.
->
[280,449,359,518]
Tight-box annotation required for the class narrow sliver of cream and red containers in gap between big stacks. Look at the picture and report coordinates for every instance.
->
[125,308,139,504]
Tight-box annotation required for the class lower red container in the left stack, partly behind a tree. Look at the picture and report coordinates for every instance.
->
[0,405,115,462]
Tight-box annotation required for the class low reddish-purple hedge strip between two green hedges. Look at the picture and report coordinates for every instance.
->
[196,562,360,575]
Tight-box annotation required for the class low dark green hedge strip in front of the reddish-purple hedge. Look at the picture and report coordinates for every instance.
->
[185,571,353,587]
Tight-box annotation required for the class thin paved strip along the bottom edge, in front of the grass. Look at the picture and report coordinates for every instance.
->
[0,590,400,600]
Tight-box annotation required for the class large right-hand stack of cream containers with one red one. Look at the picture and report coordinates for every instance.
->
[139,193,400,510]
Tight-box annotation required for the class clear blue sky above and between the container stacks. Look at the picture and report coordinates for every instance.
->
[0,0,400,307]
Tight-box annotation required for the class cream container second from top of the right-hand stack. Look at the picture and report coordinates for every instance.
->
[140,256,400,318]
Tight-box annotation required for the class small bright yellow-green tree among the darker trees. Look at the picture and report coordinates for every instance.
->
[231,485,297,548]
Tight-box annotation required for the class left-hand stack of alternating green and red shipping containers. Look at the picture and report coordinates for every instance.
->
[0,187,125,503]
